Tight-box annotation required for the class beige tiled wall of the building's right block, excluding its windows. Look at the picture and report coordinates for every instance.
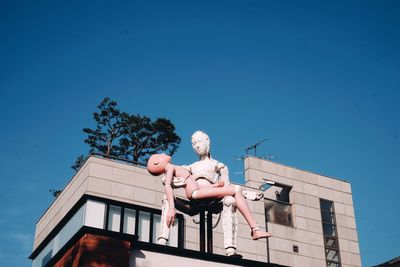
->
[245,157,361,267]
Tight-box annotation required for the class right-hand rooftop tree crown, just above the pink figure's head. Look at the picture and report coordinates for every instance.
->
[119,114,181,162]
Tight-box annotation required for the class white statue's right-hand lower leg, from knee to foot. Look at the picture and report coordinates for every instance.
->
[222,196,238,256]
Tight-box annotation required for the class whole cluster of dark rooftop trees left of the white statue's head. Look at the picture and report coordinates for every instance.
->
[71,97,181,172]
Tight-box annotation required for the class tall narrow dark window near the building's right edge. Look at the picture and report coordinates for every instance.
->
[320,199,341,267]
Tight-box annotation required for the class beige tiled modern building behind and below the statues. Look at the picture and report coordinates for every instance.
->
[30,156,361,267]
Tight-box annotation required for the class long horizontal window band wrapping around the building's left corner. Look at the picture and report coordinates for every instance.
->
[31,195,184,267]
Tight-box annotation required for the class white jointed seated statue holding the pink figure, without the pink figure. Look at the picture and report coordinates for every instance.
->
[152,131,270,256]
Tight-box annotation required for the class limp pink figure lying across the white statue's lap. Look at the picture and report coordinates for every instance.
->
[147,154,272,240]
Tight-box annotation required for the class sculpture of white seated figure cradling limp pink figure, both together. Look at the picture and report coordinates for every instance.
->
[147,131,271,256]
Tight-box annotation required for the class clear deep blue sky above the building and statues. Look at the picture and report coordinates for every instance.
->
[0,1,400,266]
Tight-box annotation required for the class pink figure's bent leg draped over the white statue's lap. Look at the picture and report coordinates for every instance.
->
[188,185,271,240]
